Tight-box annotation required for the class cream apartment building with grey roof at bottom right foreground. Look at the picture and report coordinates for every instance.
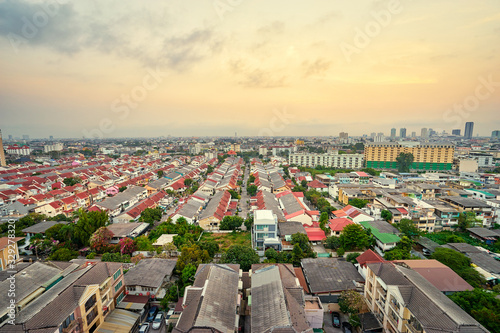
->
[364,262,488,333]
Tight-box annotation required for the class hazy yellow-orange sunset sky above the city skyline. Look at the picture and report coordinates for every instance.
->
[0,0,500,138]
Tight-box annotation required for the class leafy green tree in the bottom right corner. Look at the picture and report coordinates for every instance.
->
[449,288,500,332]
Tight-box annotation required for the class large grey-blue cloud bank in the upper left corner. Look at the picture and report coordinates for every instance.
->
[0,0,223,71]
